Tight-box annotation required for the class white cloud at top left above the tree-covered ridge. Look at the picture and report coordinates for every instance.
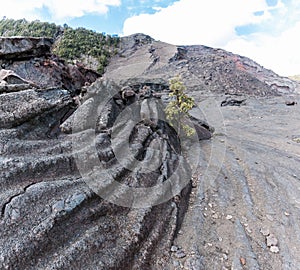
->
[0,0,121,22]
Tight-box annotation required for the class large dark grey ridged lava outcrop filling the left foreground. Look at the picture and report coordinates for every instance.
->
[0,36,212,269]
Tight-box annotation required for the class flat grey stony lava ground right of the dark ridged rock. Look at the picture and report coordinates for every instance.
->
[169,92,300,269]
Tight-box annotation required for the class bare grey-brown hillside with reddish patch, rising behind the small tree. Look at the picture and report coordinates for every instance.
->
[105,34,300,96]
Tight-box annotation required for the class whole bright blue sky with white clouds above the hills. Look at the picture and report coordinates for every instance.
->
[0,0,300,76]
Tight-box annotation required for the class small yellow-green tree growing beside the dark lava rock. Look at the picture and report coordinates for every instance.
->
[165,76,195,137]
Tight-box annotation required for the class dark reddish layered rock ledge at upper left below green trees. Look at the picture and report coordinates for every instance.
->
[0,37,99,93]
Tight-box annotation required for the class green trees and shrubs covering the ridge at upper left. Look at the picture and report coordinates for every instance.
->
[0,19,120,74]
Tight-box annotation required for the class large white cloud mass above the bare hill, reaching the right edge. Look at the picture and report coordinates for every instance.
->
[123,0,300,75]
